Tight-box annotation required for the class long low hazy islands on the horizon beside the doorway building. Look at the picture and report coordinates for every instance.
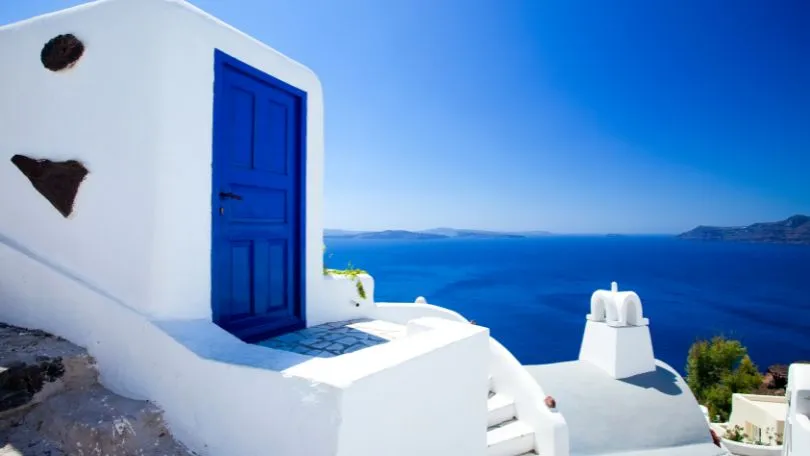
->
[324,228,551,240]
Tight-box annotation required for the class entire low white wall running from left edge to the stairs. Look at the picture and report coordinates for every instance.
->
[0,239,489,456]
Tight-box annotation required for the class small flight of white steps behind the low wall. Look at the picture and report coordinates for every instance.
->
[487,377,538,456]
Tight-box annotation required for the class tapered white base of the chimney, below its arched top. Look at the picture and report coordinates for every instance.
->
[579,320,655,378]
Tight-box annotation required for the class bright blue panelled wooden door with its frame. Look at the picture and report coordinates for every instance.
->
[211,50,306,342]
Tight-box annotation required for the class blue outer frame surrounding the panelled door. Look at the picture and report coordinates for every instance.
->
[210,49,307,340]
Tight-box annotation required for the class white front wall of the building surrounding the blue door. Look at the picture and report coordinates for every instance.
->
[146,0,331,320]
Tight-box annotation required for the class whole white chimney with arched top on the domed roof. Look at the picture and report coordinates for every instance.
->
[579,282,655,379]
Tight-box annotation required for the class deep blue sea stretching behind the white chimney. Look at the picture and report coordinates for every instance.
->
[325,236,810,372]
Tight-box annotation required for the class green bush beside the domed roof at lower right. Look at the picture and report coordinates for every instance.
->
[686,336,762,421]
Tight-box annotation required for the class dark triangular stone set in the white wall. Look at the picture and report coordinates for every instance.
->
[11,155,88,217]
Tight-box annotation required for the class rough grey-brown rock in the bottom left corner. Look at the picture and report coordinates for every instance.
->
[0,324,194,456]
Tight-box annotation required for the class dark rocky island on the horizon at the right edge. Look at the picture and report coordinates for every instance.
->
[677,215,810,245]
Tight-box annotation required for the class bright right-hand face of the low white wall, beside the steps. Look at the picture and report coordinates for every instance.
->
[338,319,489,456]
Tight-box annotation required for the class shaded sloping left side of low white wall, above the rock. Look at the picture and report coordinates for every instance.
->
[0,244,340,456]
